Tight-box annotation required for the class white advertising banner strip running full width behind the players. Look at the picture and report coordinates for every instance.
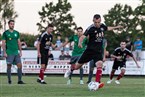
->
[0,58,145,75]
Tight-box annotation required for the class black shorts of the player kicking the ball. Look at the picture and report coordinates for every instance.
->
[78,49,103,64]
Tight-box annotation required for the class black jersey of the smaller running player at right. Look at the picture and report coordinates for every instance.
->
[113,47,133,62]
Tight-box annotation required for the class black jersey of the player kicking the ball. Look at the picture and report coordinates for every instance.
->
[84,24,107,52]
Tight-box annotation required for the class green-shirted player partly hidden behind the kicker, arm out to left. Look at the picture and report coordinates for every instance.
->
[59,27,87,85]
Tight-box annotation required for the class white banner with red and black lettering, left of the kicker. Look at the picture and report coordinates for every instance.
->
[22,59,88,74]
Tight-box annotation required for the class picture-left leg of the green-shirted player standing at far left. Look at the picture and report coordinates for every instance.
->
[6,55,14,84]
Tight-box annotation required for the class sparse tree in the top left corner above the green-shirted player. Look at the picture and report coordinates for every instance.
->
[0,0,18,31]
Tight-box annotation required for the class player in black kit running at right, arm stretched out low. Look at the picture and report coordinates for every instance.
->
[107,41,140,84]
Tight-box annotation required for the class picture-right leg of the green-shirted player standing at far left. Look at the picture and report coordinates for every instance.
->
[14,55,25,84]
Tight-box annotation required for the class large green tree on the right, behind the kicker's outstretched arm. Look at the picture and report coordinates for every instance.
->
[104,4,143,52]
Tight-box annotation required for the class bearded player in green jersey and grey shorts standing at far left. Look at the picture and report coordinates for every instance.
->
[2,20,25,84]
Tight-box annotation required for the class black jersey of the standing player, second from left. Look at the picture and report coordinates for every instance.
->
[38,32,53,52]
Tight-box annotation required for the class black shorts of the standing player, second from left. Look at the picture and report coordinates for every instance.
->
[37,53,48,66]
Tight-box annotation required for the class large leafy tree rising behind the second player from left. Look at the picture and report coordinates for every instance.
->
[37,0,76,37]
